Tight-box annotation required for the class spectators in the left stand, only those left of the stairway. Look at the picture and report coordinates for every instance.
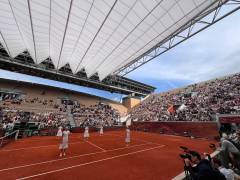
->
[0,93,69,130]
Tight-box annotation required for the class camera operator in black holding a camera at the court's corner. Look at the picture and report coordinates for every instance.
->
[184,151,226,180]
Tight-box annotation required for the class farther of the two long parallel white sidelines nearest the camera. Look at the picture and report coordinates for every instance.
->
[0,143,151,172]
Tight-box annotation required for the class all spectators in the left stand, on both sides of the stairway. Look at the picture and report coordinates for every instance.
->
[0,97,120,129]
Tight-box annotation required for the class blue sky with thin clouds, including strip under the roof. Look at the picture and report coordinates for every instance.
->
[0,8,240,101]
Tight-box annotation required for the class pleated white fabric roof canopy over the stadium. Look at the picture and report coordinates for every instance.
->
[0,0,225,80]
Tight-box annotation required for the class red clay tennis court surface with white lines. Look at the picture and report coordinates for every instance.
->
[0,131,215,180]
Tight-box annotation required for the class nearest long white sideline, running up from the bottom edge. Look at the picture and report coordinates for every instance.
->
[17,145,165,180]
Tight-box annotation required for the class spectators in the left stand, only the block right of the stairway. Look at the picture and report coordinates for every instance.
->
[72,102,120,127]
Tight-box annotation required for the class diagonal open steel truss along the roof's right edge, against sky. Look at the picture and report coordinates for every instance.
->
[113,0,240,76]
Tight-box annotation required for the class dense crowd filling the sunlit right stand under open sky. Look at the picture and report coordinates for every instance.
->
[131,74,240,121]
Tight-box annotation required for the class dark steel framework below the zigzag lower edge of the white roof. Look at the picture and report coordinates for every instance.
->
[0,43,155,97]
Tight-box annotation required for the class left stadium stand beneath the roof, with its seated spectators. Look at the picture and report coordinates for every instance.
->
[0,80,127,133]
